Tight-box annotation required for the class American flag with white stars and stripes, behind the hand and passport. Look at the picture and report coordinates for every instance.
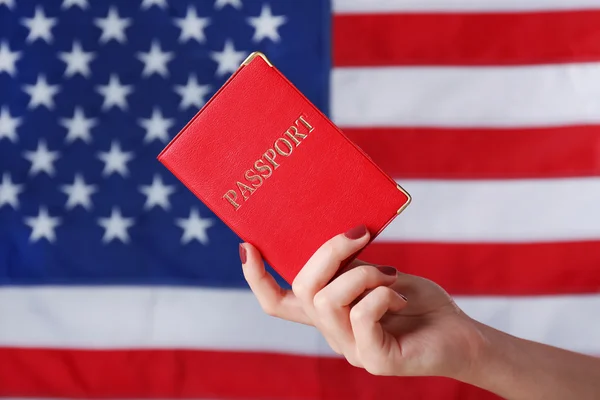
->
[0,0,600,400]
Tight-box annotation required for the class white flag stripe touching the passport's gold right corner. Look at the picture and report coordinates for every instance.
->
[384,177,600,242]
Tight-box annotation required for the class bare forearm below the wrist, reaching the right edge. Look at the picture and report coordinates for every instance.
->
[457,322,600,400]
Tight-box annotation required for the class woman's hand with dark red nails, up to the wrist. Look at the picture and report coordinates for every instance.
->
[240,227,483,377]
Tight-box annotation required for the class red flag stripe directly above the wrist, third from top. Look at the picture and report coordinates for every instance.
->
[359,239,600,295]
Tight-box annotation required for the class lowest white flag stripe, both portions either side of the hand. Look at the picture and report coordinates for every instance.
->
[0,287,600,355]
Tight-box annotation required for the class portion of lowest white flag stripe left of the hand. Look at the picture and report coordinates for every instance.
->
[0,287,318,353]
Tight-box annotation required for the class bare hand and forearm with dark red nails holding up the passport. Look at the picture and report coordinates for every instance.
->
[240,227,600,400]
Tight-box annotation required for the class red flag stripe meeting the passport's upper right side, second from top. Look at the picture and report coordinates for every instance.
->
[343,126,600,179]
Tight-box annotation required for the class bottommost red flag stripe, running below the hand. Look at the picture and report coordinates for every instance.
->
[0,348,498,400]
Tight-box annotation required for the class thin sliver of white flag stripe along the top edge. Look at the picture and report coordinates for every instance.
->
[333,0,600,14]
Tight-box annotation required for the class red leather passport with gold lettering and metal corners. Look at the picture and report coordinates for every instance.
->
[158,52,411,284]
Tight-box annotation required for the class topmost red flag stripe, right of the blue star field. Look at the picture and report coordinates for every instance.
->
[333,10,600,67]
